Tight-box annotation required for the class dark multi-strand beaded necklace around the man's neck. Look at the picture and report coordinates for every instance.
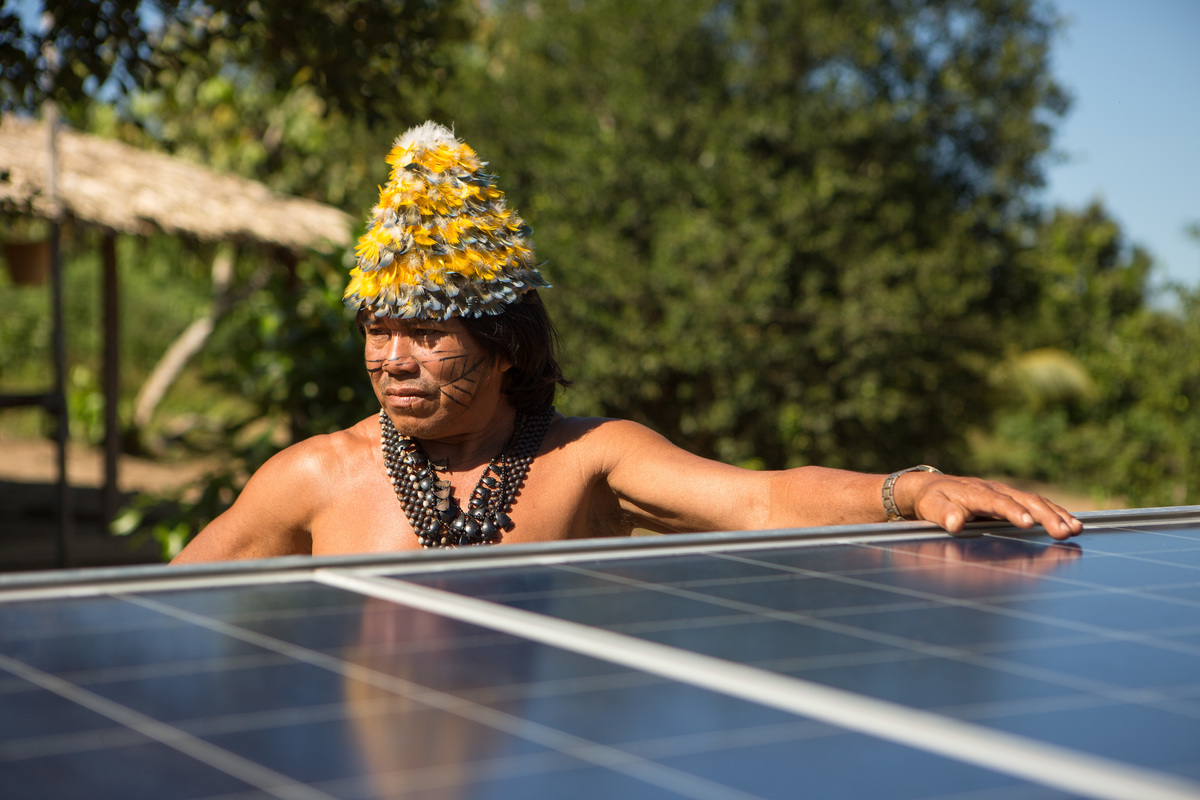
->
[379,408,554,547]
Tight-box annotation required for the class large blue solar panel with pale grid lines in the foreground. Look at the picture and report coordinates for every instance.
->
[0,507,1200,800]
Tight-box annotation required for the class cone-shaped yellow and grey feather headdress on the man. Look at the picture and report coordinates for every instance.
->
[344,122,550,319]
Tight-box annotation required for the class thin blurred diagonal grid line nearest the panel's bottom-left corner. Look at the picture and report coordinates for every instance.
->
[0,654,337,800]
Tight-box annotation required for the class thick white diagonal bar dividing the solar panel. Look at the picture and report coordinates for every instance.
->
[316,570,1200,800]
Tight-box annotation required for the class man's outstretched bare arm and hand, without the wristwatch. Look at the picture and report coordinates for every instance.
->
[598,421,1082,539]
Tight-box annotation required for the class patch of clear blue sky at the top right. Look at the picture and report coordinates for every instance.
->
[1045,0,1200,287]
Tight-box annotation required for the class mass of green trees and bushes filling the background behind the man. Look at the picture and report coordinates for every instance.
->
[11,0,1200,563]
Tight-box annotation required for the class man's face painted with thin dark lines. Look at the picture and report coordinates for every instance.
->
[364,318,509,439]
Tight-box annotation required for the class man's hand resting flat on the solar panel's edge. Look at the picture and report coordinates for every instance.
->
[895,473,1084,540]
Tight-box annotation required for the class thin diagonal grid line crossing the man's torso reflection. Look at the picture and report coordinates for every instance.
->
[124,592,756,800]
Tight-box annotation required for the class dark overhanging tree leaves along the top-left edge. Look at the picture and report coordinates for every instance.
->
[0,0,470,120]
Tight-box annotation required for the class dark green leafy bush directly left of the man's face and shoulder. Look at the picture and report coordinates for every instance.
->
[114,250,378,558]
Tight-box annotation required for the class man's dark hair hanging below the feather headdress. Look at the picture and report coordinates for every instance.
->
[462,291,571,414]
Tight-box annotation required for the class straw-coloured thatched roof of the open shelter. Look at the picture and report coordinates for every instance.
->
[0,114,353,252]
